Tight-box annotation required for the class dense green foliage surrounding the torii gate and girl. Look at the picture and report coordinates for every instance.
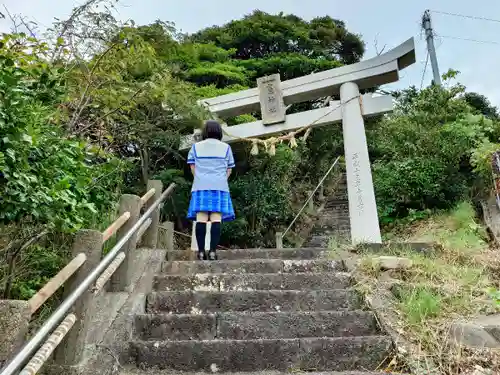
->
[0,0,500,298]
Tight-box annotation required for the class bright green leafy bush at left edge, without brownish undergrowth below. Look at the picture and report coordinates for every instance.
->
[0,36,123,231]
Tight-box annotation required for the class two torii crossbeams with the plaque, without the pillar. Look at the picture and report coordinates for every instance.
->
[180,38,415,150]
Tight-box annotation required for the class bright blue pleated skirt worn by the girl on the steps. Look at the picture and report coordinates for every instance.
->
[187,190,235,221]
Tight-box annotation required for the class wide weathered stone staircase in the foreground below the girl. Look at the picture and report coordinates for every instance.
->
[121,248,392,375]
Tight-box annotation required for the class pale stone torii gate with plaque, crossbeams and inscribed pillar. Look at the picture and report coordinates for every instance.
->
[180,38,415,244]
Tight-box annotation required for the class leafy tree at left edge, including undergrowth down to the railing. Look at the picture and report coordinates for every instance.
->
[0,34,123,298]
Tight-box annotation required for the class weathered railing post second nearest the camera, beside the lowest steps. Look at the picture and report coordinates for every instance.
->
[54,229,103,366]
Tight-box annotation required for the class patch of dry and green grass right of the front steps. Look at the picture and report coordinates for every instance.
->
[359,202,500,375]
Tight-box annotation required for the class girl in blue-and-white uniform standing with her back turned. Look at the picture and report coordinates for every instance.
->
[187,120,235,260]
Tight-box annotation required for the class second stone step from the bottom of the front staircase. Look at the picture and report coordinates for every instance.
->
[135,310,380,341]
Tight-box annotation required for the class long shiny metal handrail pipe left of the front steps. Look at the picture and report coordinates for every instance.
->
[0,184,175,375]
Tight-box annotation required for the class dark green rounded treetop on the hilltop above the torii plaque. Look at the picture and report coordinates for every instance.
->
[190,10,365,64]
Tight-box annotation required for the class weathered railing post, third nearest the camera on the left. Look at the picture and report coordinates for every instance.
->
[109,194,142,292]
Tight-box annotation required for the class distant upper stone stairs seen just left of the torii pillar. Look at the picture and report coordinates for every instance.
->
[304,173,351,247]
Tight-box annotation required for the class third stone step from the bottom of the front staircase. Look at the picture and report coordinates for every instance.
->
[146,289,361,314]
